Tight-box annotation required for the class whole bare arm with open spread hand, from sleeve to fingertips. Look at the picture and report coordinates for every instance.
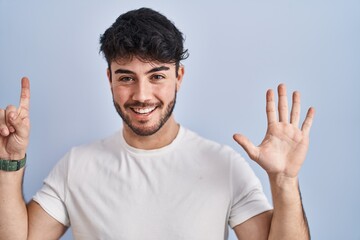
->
[234,84,315,240]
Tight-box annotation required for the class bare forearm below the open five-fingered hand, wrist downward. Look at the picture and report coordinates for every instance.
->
[269,176,310,240]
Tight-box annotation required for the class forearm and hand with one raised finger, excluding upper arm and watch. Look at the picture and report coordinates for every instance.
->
[0,78,30,240]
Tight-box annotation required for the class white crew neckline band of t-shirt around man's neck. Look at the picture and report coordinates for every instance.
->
[120,126,185,156]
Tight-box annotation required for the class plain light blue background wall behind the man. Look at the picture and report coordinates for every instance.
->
[0,0,360,240]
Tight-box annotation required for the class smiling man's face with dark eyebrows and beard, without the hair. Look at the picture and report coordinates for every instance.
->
[108,57,183,136]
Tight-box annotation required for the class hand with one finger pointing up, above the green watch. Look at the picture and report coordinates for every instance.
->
[0,77,30,160]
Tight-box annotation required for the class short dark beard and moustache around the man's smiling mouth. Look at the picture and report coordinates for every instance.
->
[113,91,177,137]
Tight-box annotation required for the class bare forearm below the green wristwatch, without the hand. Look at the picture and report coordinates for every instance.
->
[0,168,28,240]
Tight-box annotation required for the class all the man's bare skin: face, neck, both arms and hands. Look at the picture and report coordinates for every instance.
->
[0,61,314,240]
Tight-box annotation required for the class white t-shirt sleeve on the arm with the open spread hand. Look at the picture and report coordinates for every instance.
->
[229,151,272,228]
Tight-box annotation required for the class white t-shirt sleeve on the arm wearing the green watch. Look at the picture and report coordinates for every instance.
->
[33,154,70,226]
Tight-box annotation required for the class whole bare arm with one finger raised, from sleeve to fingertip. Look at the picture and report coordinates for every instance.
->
[0,78,66,240]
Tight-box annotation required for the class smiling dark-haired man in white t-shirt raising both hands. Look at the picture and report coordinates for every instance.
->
[0,8,314,240]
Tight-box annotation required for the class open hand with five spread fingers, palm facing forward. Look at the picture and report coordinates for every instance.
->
[234,84,315,178]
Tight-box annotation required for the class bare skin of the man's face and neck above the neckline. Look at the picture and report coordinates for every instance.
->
[107,58,184,149]
